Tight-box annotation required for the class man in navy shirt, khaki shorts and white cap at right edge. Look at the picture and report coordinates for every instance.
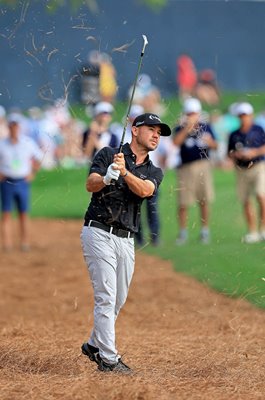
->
[228,102,265,243]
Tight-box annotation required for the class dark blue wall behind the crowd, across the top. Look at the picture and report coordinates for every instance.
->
[0,0,265,109]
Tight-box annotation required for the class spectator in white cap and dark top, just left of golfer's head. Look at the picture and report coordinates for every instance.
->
[82,101,118,160]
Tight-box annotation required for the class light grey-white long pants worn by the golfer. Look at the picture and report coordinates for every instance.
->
[81,226,135,364]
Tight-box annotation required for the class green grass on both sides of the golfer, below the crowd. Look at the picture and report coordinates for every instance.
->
[31,168,265,308]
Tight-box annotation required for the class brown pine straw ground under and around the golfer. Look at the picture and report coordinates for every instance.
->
[0,220,265,400]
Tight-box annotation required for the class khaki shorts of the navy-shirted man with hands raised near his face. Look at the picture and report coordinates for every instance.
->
[178,159,214,206]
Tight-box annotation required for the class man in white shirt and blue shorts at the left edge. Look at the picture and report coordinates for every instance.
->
[0,114,43,251]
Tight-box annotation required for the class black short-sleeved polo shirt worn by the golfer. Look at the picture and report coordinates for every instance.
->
[85,143,163,232]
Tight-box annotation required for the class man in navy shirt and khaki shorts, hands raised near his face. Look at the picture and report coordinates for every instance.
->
[173,98,217,245]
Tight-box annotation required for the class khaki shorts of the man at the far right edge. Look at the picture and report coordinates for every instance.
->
[236,161,265,203]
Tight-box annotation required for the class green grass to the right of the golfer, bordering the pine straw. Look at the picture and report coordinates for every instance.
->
[145,170,265,308]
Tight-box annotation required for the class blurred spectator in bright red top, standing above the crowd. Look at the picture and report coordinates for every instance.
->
[176,54,197,101]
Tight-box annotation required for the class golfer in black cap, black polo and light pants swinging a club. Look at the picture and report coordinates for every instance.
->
[81,113,171,373]
